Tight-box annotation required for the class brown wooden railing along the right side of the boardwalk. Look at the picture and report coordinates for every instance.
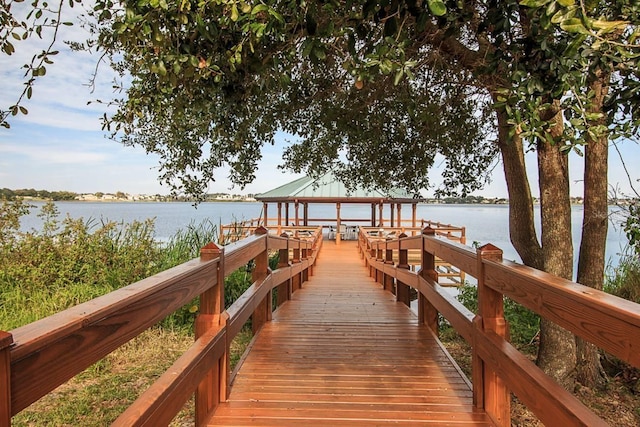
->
[359,228,640,427]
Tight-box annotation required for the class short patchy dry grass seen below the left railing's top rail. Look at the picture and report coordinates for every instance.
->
[12,328,252,427]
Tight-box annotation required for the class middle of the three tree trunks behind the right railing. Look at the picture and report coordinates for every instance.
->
[537,104,576,389]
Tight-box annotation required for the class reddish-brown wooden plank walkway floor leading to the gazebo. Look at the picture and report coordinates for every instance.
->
[209,242,492,426]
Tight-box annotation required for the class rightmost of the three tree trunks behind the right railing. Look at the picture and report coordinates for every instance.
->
[576,68,609,387]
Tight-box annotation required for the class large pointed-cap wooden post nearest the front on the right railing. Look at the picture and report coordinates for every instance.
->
[472,244,511,427]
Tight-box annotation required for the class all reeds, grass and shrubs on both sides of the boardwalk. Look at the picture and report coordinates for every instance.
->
[0,200,640,426]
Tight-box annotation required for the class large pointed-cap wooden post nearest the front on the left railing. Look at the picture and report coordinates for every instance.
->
[195,243,229,426]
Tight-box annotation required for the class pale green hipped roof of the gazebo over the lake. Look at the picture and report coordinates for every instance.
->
[255,171,421,203]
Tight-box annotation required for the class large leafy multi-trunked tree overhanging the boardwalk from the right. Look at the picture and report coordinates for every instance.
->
[5,0,640,387]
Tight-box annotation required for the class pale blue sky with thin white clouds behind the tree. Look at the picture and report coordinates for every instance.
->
[0,3,640,197]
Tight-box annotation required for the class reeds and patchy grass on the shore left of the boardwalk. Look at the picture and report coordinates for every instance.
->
[0,202,260,426]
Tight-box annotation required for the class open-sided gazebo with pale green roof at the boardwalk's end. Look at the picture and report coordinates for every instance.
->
[256,171,422,243]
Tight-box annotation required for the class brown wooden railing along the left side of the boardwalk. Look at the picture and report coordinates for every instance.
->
[0,228,322,426]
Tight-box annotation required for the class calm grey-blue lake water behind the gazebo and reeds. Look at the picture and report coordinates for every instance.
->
[17,202,626,265]
